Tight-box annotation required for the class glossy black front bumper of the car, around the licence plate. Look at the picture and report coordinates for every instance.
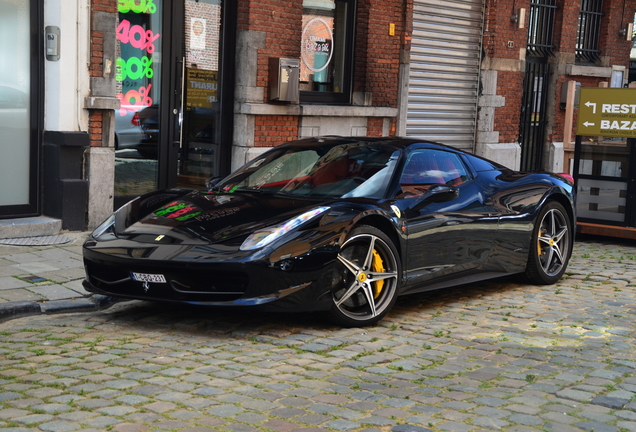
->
[83,243,335,311]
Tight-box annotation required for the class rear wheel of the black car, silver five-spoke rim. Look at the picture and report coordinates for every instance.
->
[524,201,574,285]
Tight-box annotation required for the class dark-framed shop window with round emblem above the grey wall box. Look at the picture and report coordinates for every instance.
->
[300,0,356,104]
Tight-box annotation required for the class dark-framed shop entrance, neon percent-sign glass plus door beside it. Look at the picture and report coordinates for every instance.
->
[115,0,236,207]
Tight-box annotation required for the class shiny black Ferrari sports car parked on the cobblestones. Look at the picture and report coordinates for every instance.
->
[84,137,575,326]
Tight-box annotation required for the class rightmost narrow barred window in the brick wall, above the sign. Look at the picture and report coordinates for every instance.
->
[576,0,603,63]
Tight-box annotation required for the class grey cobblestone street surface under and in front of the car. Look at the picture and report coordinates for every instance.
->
[0,238,636,432]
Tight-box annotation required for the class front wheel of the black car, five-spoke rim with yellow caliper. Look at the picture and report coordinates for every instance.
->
[331,226,402,327]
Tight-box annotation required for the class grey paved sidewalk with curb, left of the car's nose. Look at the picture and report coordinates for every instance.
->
[0,232,123,322]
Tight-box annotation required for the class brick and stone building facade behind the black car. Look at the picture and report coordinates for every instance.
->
[0,0,636,237]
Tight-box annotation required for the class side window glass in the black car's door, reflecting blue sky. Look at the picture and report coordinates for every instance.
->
[400,149,469,197]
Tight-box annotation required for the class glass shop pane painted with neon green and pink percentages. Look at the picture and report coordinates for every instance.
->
[115,0,163,196]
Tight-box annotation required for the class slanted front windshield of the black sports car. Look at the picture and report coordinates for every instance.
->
[216,143,400,198]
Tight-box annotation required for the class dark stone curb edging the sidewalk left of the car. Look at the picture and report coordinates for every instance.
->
[0,294,125,322]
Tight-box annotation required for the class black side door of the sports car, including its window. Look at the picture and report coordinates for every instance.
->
[396,148,498,285]
